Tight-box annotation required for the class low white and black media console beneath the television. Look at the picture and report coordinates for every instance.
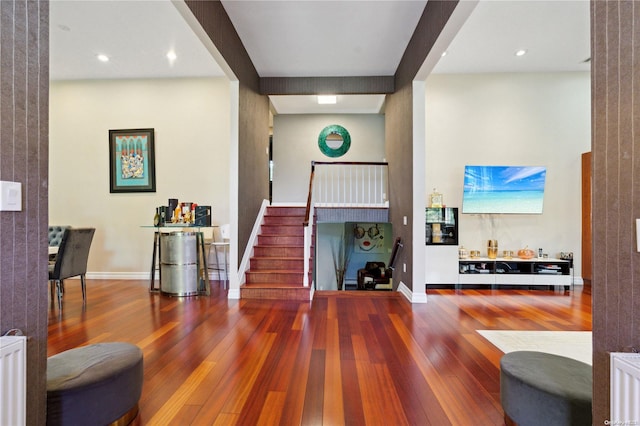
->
[458,257,573,287]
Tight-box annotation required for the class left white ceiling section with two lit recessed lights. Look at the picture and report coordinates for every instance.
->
[49,0,224,80]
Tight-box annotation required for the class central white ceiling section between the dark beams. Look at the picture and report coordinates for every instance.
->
[222,0,426,77]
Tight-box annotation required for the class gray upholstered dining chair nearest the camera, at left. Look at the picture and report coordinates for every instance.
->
[49,228,96,308]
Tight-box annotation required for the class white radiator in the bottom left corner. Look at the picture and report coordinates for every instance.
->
[0,336,27,425]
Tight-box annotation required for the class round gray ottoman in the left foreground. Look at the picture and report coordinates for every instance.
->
[47,342,143,425]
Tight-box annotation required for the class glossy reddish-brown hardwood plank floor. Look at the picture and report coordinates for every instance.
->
[48,280,591,426]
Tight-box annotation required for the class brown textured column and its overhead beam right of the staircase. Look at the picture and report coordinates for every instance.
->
[385,0,458,292]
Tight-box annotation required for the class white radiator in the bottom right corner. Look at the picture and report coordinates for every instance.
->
[610,352,640,425]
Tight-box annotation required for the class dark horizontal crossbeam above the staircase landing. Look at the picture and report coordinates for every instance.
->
[260,76,394,95]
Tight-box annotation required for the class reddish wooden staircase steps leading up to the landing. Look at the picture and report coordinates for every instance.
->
[240,206,311,300]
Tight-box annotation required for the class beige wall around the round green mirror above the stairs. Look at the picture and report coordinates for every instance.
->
[273,114,384,203]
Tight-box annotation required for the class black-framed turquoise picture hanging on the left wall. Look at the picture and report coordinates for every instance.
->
[109,129,156,193]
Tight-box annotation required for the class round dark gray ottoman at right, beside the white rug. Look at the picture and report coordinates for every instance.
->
[500,351,593,426]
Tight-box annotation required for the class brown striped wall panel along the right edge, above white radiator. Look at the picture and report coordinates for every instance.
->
[591,1,640,424]
